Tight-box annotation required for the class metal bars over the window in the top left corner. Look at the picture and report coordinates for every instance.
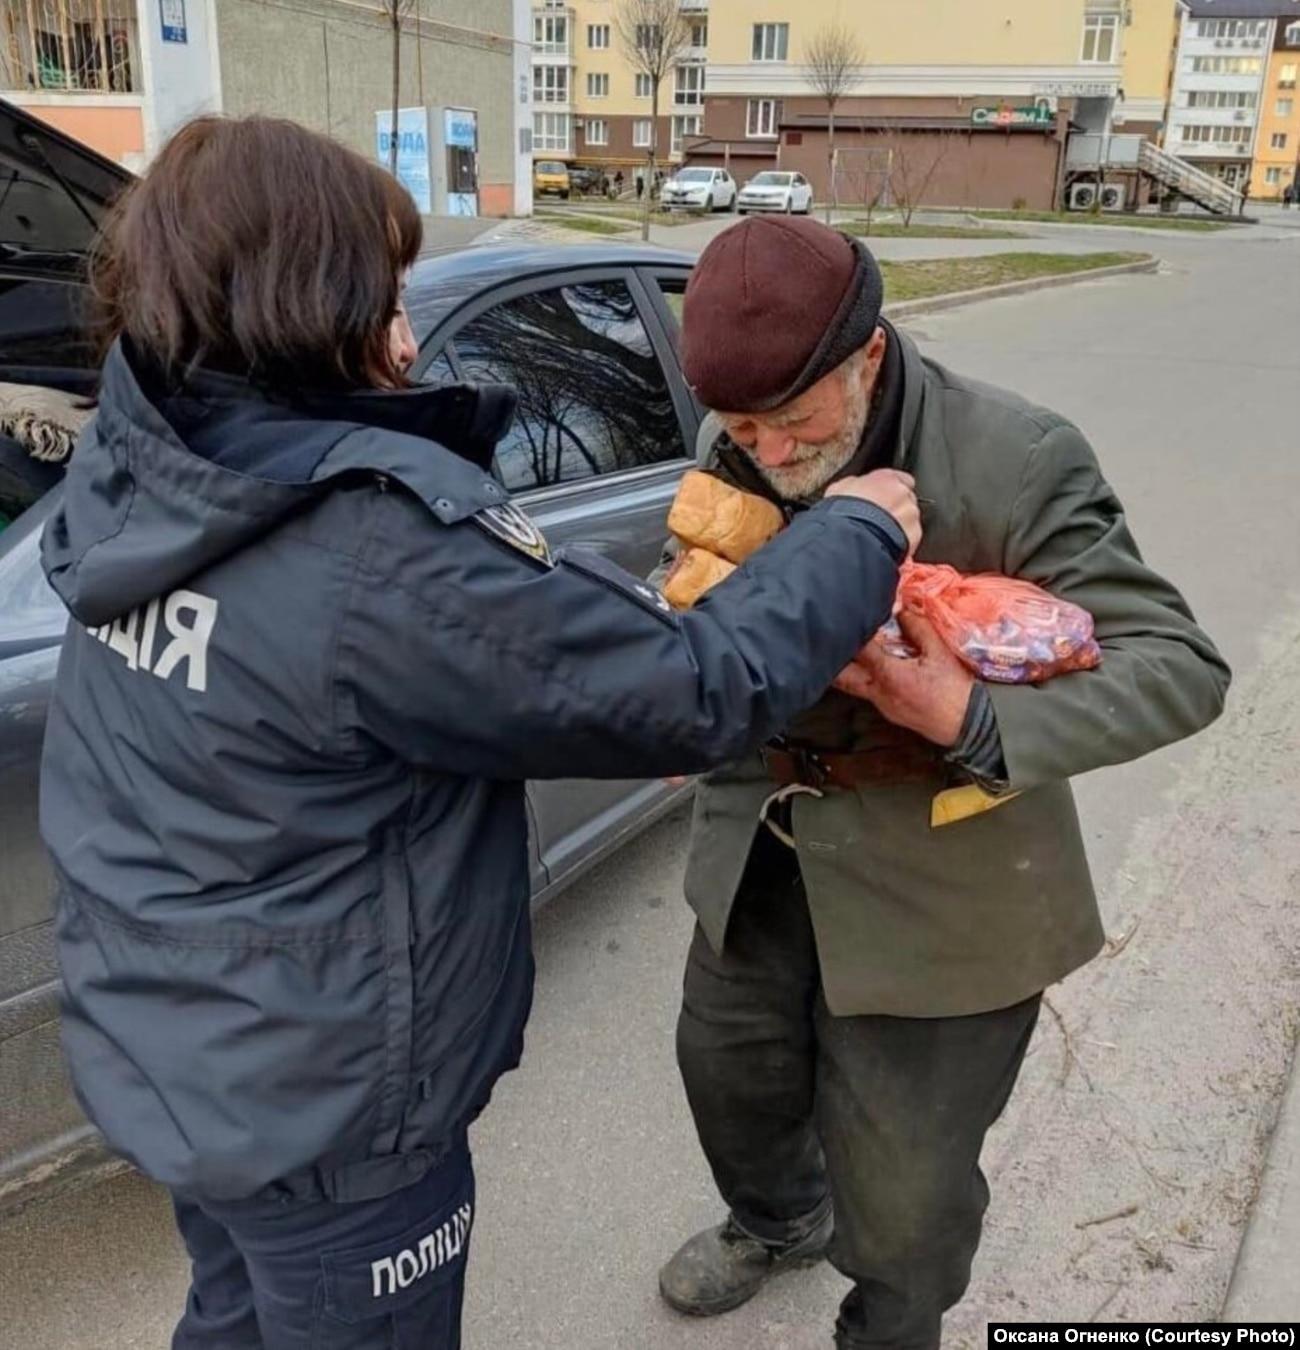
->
[0,0,142,93]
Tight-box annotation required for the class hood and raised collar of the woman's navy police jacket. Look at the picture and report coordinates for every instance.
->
[40,343,514,626]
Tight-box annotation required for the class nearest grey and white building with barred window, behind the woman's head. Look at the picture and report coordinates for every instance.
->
[0,0,532,215]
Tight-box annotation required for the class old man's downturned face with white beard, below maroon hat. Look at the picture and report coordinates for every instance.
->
[721,328,886,501]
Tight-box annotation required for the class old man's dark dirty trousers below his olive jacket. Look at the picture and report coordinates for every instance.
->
[678,830,1041,1350]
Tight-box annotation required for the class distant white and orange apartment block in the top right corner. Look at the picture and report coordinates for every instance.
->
[1165,0,1300,197]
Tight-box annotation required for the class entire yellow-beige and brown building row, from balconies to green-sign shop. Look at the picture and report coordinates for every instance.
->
[533,0,1180,208]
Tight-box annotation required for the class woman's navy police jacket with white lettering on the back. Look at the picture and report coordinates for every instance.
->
[40,346,906,1200]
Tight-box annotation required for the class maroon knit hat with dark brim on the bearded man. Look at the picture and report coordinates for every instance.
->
[682,216,884,413]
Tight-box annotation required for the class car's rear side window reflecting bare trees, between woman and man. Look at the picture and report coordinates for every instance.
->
[455,279,686,491]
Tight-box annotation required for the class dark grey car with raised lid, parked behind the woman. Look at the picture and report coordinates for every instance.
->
[0,104,699,1211]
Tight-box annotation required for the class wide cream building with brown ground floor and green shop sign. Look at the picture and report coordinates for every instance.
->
[688,0,1177,209]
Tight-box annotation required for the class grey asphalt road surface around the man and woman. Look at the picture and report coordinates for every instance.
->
[0,213,1300,1350]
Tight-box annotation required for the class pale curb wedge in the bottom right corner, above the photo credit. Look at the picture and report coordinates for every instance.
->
[1222,1026,1300,1322]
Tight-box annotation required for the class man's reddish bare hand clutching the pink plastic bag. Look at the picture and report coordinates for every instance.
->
[836,610,975,749]
